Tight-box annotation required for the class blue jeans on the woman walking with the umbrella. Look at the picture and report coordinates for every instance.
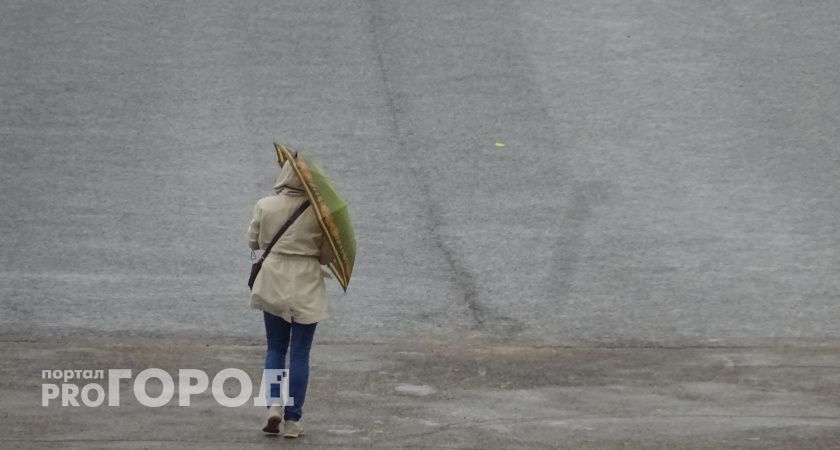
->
[263,311,318,421]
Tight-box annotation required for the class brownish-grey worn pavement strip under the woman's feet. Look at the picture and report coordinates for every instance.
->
[0,334,840,450]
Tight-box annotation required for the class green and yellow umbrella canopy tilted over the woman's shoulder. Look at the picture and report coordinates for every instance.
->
[274,143,356,292]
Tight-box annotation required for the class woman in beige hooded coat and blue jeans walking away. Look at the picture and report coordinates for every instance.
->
[248,163,333,438]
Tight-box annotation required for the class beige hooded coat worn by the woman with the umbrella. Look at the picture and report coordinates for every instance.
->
[248,164,332,324]
